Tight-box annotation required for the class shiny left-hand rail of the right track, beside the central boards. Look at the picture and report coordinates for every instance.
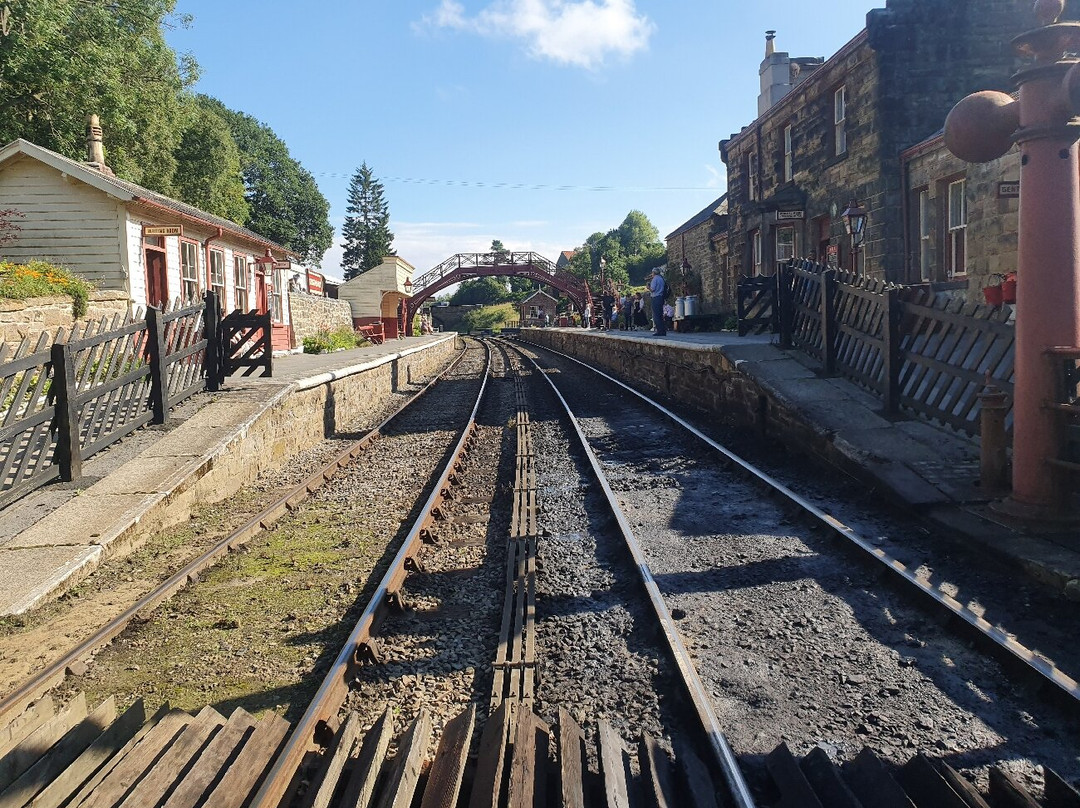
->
[507,343,754,808]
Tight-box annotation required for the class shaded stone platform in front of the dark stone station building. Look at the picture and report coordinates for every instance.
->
[518,328,1080,602]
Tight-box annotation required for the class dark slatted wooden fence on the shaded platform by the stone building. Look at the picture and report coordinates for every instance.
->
[739,260,1014,434]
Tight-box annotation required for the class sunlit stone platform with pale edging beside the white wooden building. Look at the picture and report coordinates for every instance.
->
[0,334,457,617]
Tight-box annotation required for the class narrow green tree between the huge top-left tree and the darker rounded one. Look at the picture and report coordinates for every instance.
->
[175,104,247,226]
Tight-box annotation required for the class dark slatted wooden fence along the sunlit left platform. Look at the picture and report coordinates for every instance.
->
[0,293,270,508]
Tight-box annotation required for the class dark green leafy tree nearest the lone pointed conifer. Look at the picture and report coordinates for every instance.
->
[198,95,334,266]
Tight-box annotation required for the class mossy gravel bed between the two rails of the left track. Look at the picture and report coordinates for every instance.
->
[39,348,483,718]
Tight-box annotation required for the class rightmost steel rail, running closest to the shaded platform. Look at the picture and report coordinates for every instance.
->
[520,346,1080,714]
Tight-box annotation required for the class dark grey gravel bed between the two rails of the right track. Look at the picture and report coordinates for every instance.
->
[522,339,1080,789]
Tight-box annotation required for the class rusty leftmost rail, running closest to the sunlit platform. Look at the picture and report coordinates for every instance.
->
[0,339,464,723]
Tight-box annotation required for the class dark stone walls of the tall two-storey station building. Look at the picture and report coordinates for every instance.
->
[721,0,1034,282]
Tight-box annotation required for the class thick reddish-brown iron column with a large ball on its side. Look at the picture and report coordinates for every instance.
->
[945,0,1080,517]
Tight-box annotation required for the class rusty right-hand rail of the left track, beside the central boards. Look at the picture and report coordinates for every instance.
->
[248,342,491,808]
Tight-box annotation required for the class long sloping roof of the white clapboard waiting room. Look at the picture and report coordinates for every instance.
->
[0,138,299,258]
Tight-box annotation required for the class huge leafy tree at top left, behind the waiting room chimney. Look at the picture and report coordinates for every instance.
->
[0,0,198,193]
